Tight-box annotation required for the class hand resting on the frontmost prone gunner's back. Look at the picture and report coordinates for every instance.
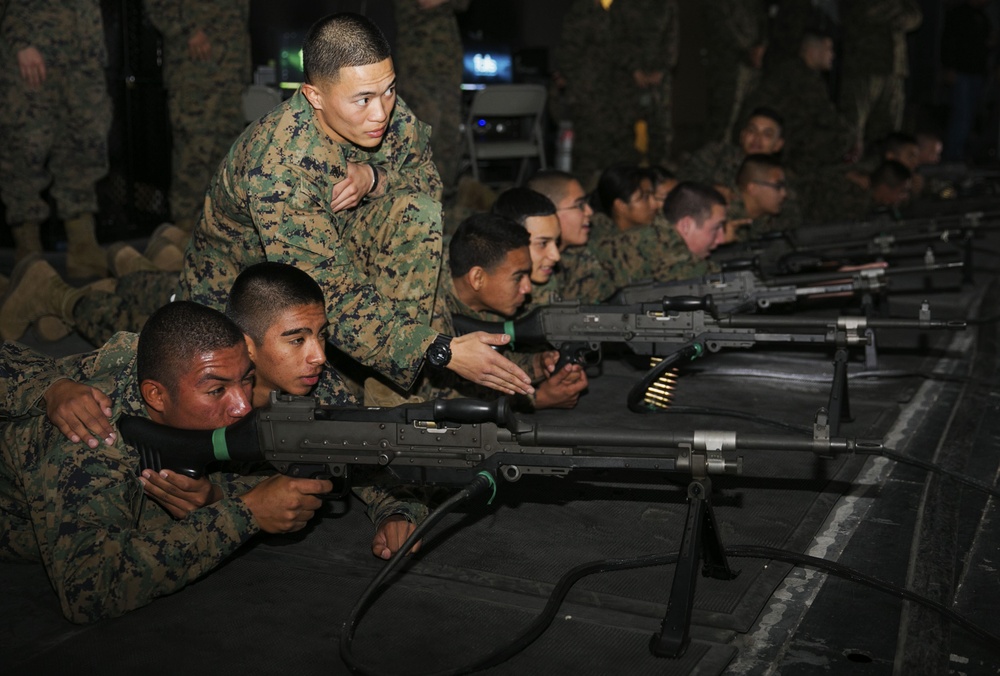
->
[42,378,115,448]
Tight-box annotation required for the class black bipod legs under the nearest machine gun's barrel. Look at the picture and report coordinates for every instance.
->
[649,477,738,657]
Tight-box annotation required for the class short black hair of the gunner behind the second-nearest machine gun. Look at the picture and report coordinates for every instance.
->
[448,213,531,278]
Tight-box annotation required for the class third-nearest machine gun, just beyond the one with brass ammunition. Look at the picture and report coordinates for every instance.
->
[608,262,962,314]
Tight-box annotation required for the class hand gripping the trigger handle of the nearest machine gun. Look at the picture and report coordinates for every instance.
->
[240,474,333,533]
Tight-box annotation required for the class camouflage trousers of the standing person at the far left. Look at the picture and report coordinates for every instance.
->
[0,64,111,225]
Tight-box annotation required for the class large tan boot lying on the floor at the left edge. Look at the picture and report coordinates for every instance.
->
[0,254,87,340]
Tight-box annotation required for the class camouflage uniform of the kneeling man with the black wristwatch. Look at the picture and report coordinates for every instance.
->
[178,90,441,388]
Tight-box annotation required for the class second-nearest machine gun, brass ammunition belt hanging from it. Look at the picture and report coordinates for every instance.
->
[452,296,965,425]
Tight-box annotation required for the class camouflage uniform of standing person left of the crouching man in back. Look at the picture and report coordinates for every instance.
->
[698,0,767,144]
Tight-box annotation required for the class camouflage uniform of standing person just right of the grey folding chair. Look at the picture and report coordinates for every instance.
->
[552,0,635,185]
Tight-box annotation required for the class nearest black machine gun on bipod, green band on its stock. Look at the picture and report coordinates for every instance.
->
[119,392,882,657]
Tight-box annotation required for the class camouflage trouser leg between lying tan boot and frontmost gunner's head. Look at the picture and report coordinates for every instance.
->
[73,272,177,347]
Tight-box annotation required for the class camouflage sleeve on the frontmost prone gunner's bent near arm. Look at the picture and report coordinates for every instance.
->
[22,418,259,623]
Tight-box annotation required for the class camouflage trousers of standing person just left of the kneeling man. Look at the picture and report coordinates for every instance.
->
[165,60,246,221]
